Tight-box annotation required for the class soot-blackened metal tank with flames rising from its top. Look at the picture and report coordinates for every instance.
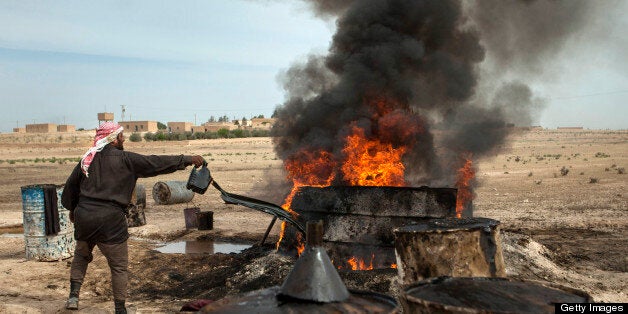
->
[278,186,464,270]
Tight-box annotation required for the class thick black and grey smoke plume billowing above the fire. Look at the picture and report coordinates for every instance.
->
[272,0,589,190]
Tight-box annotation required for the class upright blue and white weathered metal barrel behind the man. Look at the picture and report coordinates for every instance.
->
[21,185,76,261]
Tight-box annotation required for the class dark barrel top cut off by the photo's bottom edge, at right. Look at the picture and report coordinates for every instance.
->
[399,276,592,313]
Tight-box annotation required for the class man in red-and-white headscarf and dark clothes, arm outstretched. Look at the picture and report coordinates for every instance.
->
[61,122,205,313]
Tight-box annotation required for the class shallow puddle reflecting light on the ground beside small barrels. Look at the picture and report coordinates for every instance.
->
[155,241,252,254]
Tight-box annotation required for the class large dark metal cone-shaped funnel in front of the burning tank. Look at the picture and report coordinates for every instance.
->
[277,221,350,302]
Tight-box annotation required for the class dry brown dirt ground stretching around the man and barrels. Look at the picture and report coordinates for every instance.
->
[0,130,628,313]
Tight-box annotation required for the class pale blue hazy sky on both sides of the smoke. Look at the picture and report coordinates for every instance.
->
[0,0,628,132]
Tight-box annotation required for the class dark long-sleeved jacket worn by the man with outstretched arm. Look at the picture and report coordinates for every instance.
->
[61,144,192,243]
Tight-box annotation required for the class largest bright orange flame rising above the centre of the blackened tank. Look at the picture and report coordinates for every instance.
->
[342,126,406,186]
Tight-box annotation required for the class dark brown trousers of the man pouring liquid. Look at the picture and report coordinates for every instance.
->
[70,241,129,301]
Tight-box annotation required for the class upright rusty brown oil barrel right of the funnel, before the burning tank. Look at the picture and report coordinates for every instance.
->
[393,217,506,284]
